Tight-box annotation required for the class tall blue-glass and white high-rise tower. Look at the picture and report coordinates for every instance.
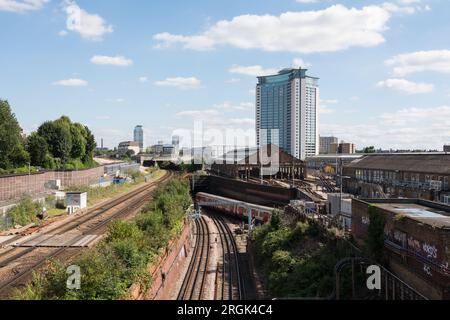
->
[256,68,320,160]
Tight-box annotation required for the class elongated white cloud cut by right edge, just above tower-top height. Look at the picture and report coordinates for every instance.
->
[385,50,450,76]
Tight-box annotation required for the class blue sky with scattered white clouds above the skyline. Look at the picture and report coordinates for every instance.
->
[0,0,450,150]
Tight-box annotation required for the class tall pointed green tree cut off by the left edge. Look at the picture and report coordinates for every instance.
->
[0,100,29,169]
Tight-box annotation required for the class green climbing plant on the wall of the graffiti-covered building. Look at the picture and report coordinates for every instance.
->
[366,205,386,261]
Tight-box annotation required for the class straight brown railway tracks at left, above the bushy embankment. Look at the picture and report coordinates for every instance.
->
[0,172,173,298]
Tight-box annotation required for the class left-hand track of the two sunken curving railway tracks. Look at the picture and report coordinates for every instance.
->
[177,217,210,300]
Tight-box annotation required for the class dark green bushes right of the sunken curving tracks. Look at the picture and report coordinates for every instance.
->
[253,213,358,298]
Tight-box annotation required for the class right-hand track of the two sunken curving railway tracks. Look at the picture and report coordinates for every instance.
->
[211,214,246,300]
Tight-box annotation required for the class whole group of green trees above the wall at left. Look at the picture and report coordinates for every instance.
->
[0,100,96,174]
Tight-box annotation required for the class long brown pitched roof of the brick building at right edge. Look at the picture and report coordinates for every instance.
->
[346,153,450,175]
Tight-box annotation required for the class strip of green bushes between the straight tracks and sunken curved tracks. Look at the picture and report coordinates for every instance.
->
[15,180,191,300]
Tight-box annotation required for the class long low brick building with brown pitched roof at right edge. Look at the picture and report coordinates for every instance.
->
[343,153,450,201]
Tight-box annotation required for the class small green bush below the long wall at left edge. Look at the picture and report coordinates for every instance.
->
[0,198,42,229]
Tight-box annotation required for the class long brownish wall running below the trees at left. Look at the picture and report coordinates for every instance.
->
[0,166,104,201]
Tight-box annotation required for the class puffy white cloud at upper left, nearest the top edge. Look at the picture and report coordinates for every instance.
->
[64,0,113,40]
